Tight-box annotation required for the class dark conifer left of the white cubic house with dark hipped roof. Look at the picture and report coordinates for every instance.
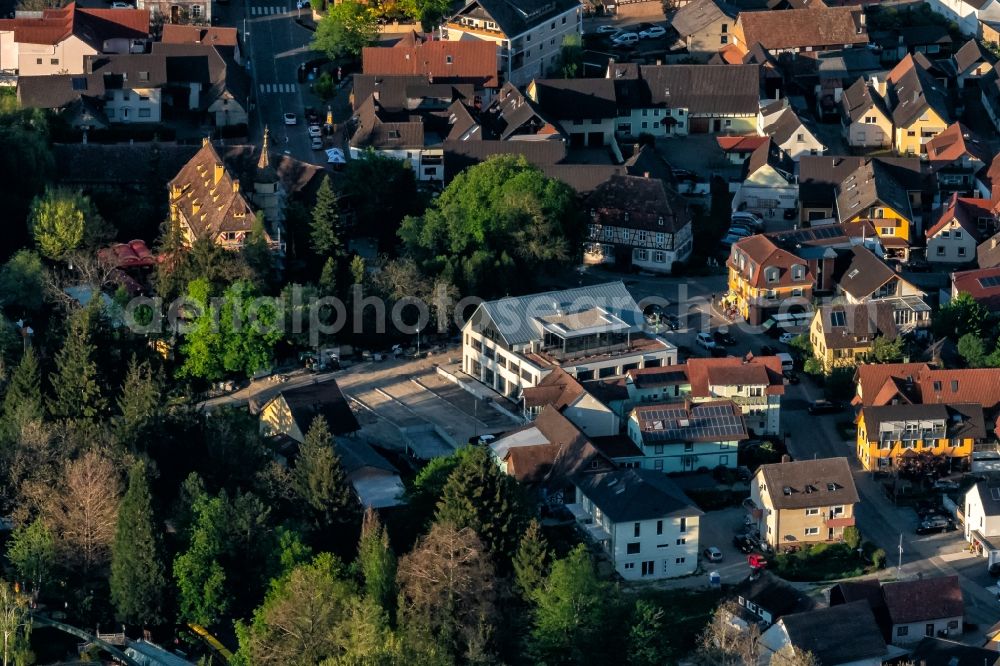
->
[436,440,528,571]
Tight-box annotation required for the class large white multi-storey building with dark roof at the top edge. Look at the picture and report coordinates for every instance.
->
[441,0,583,86]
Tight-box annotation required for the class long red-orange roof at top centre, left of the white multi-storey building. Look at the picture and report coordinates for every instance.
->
[361,40,500,88]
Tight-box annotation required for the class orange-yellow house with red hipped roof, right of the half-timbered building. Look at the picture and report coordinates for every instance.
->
[726,234,813,326]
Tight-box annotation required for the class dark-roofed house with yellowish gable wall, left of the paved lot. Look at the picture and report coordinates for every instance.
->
[251,379,360,443]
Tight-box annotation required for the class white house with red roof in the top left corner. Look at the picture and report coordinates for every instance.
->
[0,3,149,76]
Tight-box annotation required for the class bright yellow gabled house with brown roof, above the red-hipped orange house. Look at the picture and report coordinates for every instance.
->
[836,160,913,260]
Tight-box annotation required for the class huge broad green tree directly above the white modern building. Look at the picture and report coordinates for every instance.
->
[399,155,583,296]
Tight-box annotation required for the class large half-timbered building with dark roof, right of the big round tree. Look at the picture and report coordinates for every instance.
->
[583,175,692,273]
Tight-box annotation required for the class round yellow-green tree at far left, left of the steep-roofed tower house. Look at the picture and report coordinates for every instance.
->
[29,188,109,260]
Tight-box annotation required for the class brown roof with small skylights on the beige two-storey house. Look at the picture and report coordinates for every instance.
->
[755,458,858,510]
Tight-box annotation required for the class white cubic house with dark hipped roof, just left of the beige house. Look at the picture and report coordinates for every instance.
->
[568,469,703,580]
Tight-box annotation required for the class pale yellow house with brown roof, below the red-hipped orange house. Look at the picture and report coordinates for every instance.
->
[809,301,897,372]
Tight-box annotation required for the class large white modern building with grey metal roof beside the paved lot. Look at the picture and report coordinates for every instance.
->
[462,282,677,398]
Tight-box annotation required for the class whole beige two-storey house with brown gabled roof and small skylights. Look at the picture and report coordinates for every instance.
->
[747,458,859,550]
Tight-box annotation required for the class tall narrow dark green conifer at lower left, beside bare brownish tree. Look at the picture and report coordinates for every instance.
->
[174,496,232,625]
